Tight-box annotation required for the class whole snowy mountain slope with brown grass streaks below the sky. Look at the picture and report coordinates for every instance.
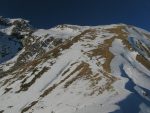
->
[0,17,150,113]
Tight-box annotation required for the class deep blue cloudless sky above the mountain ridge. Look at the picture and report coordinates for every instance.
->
[0,0,150,31]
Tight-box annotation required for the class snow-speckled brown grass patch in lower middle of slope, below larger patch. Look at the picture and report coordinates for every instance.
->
[64,62,117,95]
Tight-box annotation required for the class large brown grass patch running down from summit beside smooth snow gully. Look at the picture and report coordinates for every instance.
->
[86,26,132,73]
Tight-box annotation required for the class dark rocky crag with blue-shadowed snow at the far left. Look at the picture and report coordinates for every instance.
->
[0,17,33,63]
